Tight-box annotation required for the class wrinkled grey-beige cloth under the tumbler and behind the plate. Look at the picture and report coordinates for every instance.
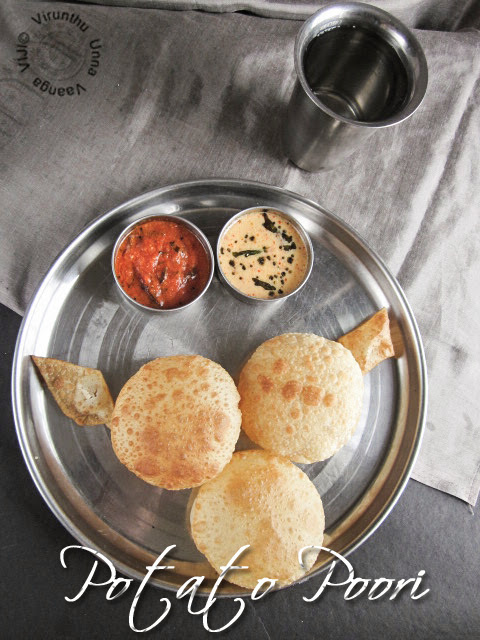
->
[0,0,480,504]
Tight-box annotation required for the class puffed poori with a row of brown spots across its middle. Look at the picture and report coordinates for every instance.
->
[238,333,363,463]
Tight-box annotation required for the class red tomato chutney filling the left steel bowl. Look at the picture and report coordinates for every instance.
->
[114,219,210,309]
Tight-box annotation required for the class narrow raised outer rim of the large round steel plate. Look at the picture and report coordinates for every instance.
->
[11,178,428,597]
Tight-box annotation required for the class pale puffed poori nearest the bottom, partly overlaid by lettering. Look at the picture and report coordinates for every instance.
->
[190,450,325,589]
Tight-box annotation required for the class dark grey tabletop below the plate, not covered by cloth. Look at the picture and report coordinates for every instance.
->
[0,306,480,640]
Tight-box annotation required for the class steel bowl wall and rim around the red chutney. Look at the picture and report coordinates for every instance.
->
[111,215,215,314]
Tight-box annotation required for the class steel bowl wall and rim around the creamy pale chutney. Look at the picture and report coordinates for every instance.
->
[215,205,313,304]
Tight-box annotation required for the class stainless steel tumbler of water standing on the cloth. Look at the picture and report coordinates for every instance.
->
[284,2,428,171]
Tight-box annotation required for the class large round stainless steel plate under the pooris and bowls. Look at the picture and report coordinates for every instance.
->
[13,180,426,594]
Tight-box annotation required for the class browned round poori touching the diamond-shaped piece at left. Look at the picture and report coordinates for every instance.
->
[111,355,241,489]
